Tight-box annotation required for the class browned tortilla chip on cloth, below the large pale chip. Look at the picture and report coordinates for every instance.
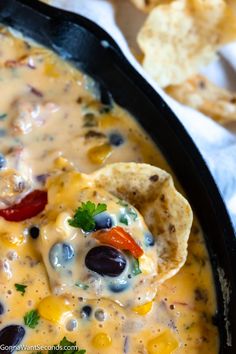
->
[166,75,236,124]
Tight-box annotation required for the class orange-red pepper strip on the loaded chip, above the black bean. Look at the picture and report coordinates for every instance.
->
[94,226,143,258]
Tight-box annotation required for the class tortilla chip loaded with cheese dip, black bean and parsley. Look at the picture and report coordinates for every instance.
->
[36,163,192,307]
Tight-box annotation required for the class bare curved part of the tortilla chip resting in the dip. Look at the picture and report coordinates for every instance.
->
[91,163,192,282]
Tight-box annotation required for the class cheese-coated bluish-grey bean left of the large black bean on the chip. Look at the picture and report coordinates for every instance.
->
[49,242,75,268]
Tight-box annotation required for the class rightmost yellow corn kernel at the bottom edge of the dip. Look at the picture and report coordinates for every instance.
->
[147,330,178,354]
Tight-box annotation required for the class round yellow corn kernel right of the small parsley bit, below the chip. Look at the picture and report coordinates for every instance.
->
[38,296,71,324]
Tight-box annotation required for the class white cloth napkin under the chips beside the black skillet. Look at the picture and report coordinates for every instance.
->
[50,0,236,227]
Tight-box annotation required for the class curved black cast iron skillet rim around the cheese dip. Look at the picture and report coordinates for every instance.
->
[0,0,236,354]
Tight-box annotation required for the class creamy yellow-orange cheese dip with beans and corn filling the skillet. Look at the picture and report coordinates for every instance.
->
[0,28,219,354]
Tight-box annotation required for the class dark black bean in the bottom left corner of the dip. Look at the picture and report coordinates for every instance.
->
[0,325,25,354]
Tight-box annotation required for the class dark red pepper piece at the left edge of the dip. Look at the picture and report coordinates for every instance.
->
[0,190,48,221]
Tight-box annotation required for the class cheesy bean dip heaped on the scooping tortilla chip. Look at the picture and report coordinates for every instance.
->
[37,171,157,306]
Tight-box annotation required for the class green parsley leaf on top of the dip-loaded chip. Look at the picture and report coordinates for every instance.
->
[68,201,107,232]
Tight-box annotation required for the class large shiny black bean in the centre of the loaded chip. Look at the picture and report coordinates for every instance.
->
[85,246,126,277]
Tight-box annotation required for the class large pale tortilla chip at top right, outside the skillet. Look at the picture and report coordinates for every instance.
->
[137,0,236,87]
